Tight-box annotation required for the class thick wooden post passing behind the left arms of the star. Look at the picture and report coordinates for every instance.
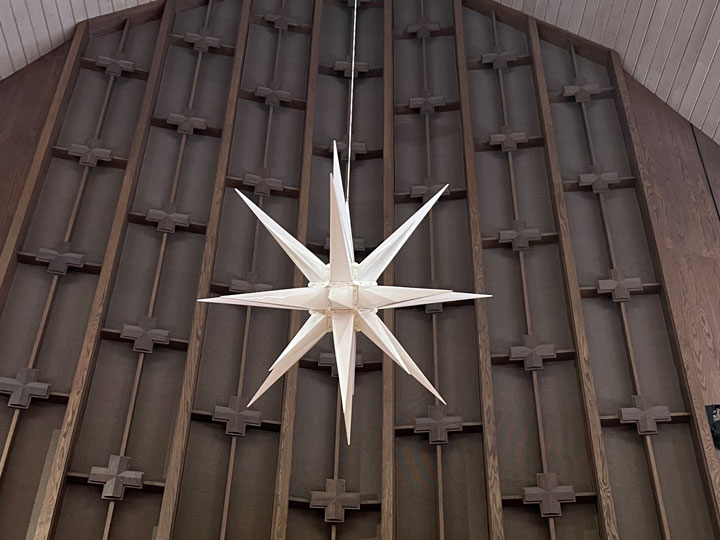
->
[271,0,323,540]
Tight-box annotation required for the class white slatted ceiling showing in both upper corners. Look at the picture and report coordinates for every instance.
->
[0,0,720,143]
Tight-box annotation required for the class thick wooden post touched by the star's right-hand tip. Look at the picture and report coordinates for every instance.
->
[453,0,505,540]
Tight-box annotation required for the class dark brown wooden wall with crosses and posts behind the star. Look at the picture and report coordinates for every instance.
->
[0,0,719,540]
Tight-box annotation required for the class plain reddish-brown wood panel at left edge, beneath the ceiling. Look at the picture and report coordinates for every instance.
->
[0,43,70,245]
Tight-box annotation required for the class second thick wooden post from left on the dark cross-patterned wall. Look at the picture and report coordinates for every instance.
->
[31,0,175,540]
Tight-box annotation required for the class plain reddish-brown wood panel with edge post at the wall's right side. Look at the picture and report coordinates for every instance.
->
[609,49,720,534]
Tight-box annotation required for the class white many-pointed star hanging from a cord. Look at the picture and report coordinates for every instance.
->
[199,143,490,444]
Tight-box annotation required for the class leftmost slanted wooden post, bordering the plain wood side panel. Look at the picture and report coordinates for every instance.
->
[0,21,89,310]
